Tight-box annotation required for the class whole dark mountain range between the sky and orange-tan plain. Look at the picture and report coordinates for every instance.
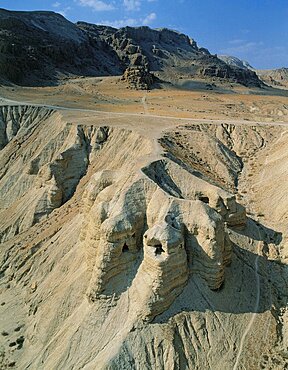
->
[0,9,261,87]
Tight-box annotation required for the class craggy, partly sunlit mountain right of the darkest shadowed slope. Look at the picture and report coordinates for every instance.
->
[77,22,261,86]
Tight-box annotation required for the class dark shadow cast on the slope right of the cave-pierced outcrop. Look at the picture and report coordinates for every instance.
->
[154,219,288,323]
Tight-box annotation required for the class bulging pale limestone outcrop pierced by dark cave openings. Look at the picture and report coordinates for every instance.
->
[80,150,246,320]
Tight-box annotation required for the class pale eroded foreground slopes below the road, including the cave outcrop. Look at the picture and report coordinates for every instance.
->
[0,106,287,370]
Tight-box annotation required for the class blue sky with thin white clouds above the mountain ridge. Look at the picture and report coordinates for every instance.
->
[0,0,288,68]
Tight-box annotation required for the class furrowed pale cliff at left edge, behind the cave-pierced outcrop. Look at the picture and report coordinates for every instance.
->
[0,106,108,241]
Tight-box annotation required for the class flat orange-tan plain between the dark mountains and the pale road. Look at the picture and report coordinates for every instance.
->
[0,76,288,122]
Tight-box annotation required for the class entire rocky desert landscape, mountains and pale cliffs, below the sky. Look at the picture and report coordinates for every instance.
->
[0,9,288,370]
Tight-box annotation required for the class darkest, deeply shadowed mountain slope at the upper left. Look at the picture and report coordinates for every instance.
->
[0,9,121,85]
